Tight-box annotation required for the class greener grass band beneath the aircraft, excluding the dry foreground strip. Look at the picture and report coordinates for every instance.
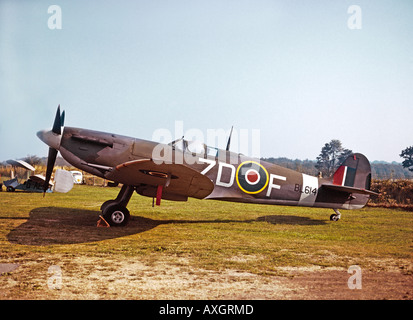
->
[0,186,413,275]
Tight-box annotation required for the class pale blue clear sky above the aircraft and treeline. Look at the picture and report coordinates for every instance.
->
[0,0,413,162]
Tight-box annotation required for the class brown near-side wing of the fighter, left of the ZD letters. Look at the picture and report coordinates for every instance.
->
[105,159,214,199]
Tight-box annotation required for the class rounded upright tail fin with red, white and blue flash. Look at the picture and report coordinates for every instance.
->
[333,153,371,190]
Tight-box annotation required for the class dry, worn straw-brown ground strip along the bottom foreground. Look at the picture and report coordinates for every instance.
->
[0,255,413,300]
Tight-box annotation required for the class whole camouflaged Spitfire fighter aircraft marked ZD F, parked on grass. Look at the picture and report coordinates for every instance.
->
[37,105,376,226]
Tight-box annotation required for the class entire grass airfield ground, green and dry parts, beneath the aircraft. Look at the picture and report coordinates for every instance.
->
[0,186,413,300]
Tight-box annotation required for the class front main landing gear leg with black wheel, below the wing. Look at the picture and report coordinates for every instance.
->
[100,185,135,227]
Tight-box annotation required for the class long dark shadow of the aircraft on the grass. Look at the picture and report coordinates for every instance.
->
[7,207,326,246]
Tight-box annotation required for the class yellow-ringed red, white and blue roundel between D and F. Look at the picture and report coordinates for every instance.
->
[236,161,268,194]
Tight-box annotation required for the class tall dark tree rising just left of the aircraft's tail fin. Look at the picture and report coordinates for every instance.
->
[315,139,352,177]
